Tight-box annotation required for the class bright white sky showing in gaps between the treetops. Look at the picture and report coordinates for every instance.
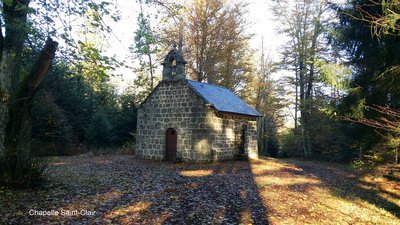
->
[107,0,283,89]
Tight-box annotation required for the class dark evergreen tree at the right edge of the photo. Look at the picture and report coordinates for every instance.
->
[334,0,400,163]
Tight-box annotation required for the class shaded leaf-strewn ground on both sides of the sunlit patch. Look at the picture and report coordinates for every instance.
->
[7,157,400,224]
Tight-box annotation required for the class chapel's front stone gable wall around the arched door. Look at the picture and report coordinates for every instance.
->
[136,80,209,161]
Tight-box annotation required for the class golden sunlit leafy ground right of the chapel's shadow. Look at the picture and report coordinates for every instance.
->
[251,159,400,224]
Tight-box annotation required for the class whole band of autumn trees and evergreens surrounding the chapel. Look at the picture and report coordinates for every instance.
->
[0,0,400,186]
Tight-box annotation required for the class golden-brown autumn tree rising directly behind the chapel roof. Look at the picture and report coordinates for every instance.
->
[155,0,253,93]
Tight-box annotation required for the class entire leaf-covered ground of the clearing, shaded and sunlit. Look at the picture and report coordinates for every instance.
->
[0,156,400,224]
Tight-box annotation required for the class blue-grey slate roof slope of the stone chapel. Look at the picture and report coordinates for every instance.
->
[187,80,262,116]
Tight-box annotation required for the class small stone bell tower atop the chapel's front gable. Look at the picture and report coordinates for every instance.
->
[161,45,186,80]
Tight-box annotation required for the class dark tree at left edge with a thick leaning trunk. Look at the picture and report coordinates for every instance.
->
[0,0,119,186]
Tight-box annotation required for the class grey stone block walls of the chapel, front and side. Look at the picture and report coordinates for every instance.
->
[136,79,257,161]
